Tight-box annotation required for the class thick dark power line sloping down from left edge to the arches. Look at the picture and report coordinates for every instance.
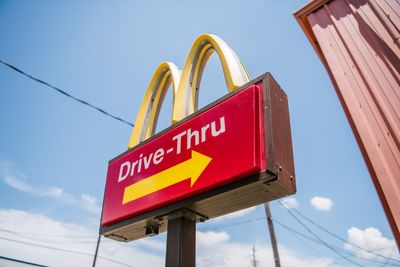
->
[0,59,134,127]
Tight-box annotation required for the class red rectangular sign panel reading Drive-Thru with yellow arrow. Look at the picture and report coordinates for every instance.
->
[101,85,266,226]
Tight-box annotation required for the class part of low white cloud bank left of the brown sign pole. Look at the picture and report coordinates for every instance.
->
[0,209,165,267]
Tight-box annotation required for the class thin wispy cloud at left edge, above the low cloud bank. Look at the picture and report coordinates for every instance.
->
[0,161,100,214]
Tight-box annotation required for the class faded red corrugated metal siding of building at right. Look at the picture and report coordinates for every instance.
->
[295,0,400,246]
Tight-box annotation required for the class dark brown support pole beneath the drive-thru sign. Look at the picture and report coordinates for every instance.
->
[165,212,196,267]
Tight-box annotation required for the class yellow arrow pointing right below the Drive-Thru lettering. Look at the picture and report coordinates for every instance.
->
[122,150,212,204]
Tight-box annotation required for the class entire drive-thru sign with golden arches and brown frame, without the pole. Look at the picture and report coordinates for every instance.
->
[100,34,296,241]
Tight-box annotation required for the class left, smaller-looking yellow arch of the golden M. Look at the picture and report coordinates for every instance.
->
[128,62,181,149]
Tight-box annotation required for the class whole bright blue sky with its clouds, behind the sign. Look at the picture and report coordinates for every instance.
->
[0,0,400,266]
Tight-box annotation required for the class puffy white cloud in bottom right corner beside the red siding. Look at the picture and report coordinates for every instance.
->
[344,227,400,260]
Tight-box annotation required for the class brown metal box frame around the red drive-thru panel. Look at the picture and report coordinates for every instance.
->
[100,72,296,242]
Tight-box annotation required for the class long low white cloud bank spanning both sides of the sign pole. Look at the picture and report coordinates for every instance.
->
[0,209,337,267]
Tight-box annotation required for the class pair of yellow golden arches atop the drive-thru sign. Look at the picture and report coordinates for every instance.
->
[128,34,250,149]
